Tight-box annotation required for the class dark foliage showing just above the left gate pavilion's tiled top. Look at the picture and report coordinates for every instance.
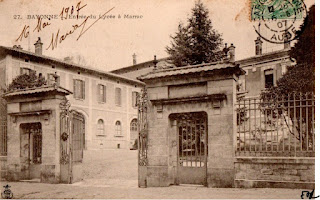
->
[8,70,46,91]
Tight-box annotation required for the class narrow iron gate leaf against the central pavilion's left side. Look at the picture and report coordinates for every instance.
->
[137,88,148,187]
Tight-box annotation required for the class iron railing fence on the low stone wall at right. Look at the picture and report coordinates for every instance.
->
[236,93,315,157]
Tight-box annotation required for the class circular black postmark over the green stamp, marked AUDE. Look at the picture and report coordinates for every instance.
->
[251,0,307,44]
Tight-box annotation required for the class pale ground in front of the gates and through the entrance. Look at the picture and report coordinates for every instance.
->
[1,150,302,199]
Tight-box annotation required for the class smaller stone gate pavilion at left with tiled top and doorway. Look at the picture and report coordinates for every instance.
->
[4,85,71,183]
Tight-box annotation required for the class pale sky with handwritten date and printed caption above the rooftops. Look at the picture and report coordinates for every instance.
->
[0,0,314,71]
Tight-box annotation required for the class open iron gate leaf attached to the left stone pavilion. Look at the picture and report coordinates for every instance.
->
[60,99,85,183]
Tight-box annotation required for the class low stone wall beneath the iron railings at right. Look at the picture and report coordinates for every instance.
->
[235,157,315,189]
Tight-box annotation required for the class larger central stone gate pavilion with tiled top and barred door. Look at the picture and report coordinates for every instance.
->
[139,62,243,187]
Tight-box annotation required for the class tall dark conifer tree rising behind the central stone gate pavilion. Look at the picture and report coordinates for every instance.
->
[166,1,222,67]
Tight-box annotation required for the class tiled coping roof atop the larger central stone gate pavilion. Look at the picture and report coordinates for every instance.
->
[138,61,244,80]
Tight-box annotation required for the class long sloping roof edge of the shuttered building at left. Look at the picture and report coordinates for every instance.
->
[0,46,144,85]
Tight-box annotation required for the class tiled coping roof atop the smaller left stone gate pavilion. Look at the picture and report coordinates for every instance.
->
[3,85,72,98]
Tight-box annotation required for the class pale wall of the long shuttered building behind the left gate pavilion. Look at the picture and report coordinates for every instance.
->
[0,55,141,149]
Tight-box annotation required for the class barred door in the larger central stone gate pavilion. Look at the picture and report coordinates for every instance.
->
[176,112,208,185]
